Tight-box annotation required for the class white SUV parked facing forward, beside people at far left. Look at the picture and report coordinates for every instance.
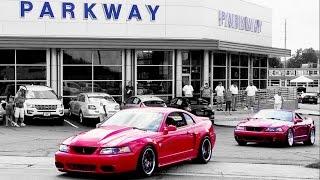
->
[16,85,64,125]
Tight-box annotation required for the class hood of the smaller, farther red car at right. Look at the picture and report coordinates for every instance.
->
[239,119,292,127]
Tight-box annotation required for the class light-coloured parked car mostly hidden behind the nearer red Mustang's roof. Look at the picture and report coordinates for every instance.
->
[121,96,167,109]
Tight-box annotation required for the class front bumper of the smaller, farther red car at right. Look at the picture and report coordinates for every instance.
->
[234,130,287,143]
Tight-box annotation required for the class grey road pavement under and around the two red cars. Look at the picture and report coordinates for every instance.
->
[0,116,320,180]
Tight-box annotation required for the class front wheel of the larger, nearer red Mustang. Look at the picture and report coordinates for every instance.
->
[137,146,158,177]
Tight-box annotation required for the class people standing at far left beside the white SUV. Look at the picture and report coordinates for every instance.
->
[1,87,26,127]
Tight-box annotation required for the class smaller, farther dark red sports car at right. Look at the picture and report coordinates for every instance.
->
[234,109,316,146]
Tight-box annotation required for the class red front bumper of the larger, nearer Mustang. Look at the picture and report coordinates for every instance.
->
[55,151,138,174]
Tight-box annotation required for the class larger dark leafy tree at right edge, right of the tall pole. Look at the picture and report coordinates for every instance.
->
[287,48,318,68]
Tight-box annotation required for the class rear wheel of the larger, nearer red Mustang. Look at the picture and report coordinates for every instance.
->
[196,137,212,164]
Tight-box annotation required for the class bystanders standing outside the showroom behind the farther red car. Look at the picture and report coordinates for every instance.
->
[182,82,283,114]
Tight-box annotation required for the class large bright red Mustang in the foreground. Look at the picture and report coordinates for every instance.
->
[55,108,216,176]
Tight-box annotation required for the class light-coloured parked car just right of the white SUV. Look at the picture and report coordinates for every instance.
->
[69,93,120,123]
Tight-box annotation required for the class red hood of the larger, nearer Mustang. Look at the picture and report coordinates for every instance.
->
[64,126,154,147]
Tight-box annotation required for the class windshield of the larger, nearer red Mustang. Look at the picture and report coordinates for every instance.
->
[101,111,163,132]
